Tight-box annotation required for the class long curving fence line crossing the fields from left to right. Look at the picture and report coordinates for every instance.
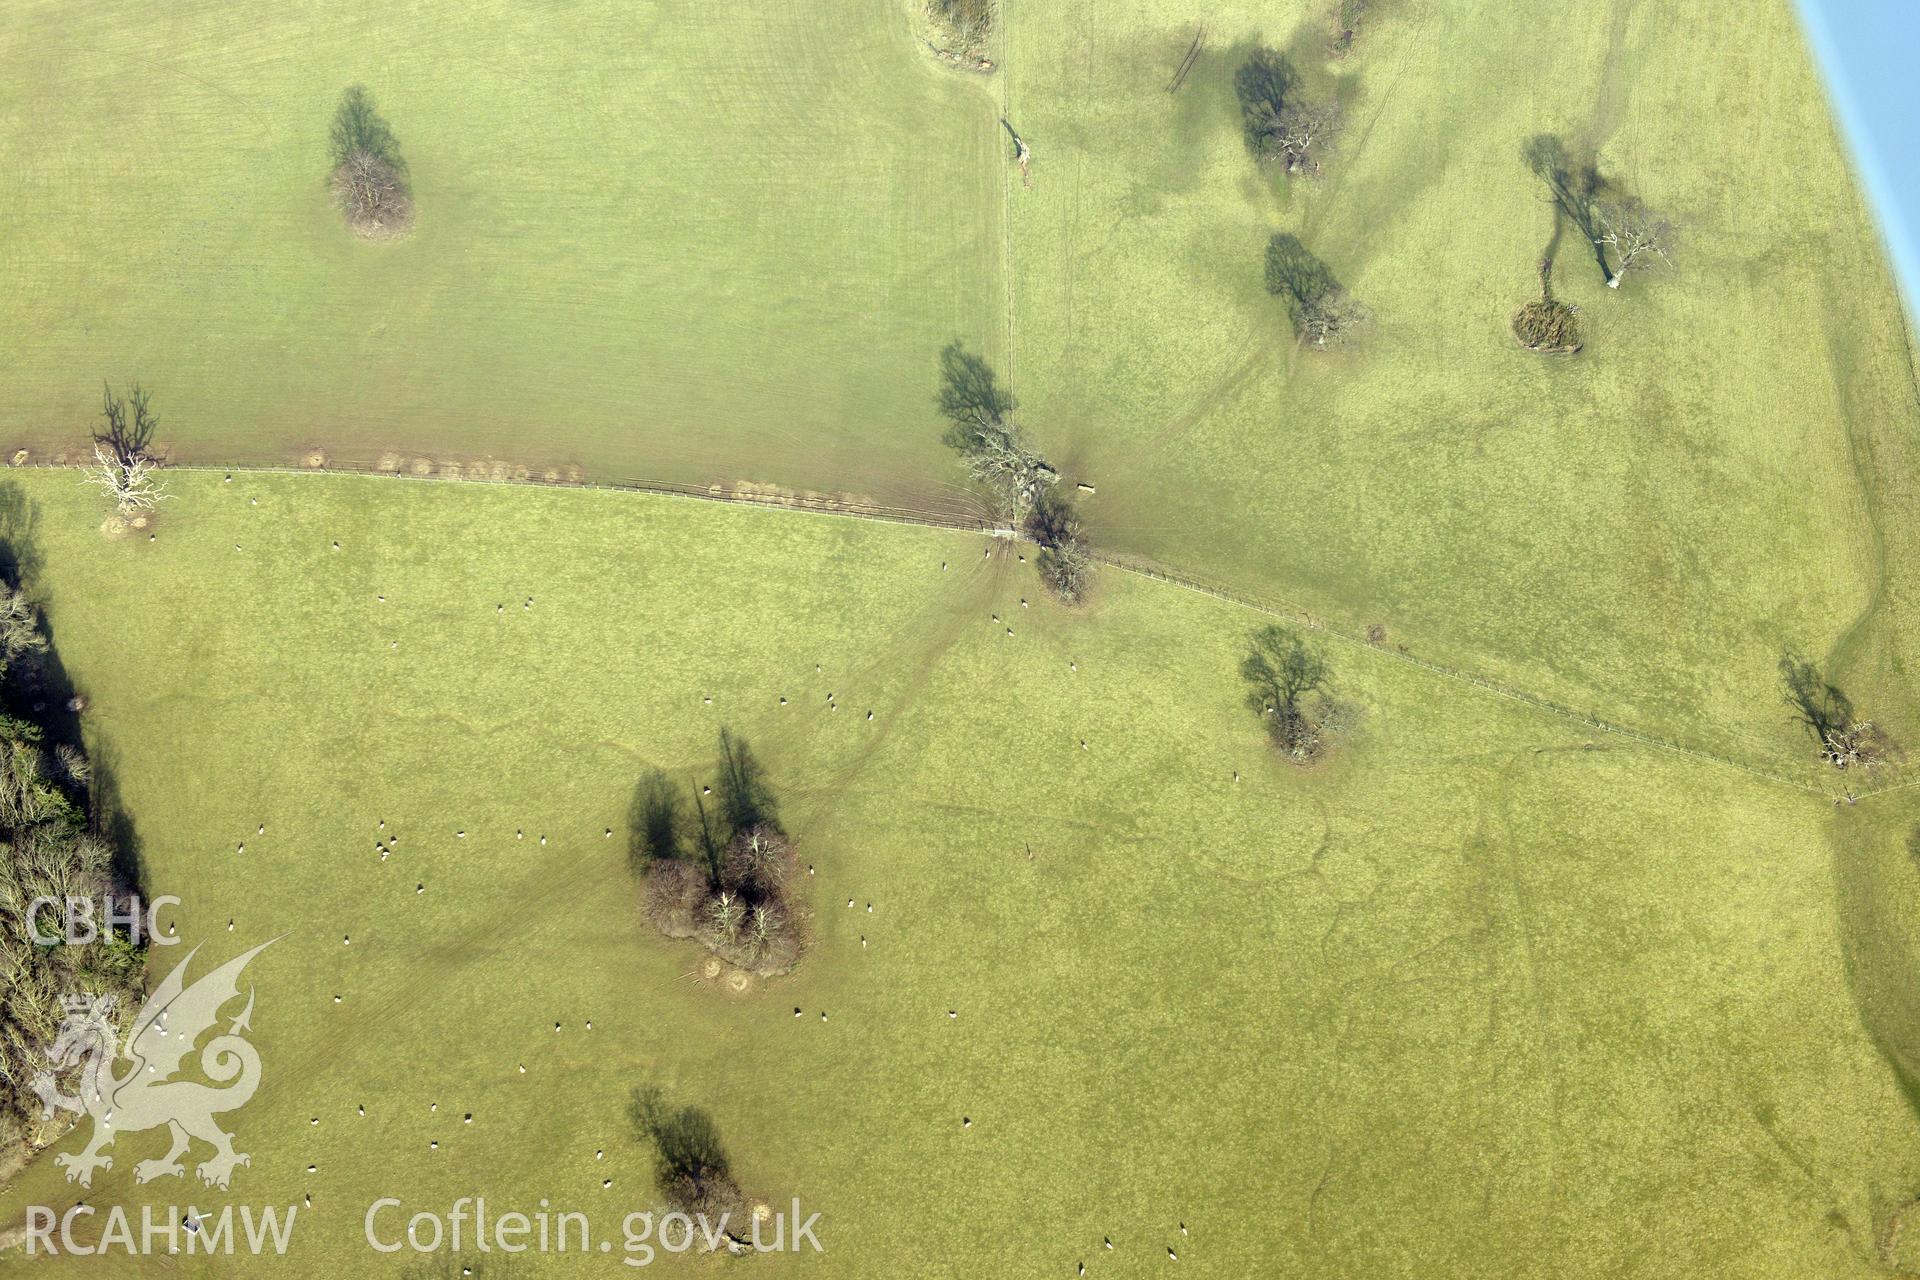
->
[30,461,1920,802]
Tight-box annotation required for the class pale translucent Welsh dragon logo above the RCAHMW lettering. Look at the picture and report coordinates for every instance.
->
[31,938,278,1188]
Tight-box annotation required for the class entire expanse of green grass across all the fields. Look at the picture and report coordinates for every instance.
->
[0,0,1920,1278]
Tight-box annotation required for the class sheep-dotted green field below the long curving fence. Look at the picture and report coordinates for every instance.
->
[8,472,1920,1276]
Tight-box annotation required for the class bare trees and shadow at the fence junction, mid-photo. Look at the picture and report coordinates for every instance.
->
[937,342,1092,604]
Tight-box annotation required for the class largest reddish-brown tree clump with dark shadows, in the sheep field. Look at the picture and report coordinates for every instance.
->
[630,729,806,977]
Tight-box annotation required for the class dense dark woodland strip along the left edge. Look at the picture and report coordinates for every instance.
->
[0,583,144,1148]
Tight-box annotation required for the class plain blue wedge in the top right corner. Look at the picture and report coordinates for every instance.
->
[1799,0,1920,317]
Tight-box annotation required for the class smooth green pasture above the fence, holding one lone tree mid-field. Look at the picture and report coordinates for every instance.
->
[0,0,1006,507]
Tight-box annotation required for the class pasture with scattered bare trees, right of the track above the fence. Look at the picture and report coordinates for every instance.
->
[1004,0,1920,760]
